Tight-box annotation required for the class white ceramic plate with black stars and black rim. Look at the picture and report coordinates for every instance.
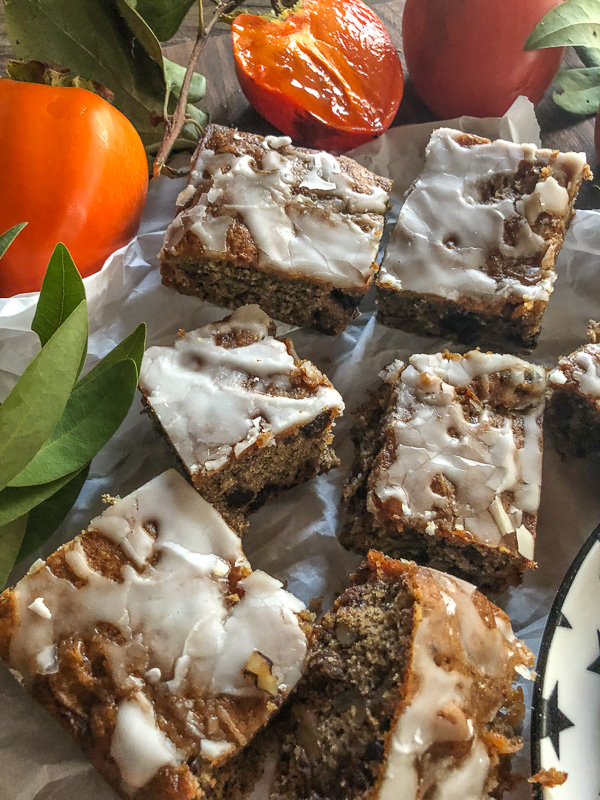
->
[531,525,600,800]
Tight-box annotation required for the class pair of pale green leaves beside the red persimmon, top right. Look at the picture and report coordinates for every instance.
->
[525,0,600,115]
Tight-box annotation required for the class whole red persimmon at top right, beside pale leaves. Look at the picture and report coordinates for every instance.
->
[402,0,564,118]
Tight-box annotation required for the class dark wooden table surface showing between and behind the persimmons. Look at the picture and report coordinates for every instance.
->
[0,0,600,208]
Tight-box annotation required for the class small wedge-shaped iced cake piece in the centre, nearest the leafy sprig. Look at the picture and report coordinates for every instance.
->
[140,306,344,529]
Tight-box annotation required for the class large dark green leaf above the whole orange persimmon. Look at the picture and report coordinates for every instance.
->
[4,0,200,151]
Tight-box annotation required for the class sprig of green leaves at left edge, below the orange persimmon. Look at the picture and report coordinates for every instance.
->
[0,231,146,588]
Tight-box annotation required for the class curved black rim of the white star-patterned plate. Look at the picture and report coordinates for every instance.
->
[530,523,600,798]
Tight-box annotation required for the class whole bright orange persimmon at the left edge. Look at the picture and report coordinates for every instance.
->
[0,79,148,297]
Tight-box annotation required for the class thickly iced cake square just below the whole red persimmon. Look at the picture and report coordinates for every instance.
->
[377,128,592,350]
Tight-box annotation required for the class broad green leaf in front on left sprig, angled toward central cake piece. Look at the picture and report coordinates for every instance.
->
[10,358,138,487]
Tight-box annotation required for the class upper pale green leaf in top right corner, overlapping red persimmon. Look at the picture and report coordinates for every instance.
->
[525,0,600,50]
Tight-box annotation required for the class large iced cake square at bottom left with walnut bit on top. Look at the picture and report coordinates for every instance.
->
[0,471,308,800]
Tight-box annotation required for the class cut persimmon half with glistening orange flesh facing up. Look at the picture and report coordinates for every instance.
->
[232,0,404,152]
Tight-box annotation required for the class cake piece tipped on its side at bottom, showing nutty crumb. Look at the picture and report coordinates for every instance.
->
[221,551,533,800]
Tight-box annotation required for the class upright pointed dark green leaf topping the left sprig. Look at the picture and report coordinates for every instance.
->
[31,244,85,347]
